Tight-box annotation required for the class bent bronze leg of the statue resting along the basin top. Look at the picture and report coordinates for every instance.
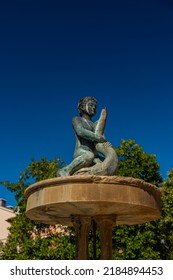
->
[57,151,94,177]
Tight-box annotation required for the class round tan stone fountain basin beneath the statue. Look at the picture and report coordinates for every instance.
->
[25,175,161,225]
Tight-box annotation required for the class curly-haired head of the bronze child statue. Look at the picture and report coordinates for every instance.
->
[78,96,97,117]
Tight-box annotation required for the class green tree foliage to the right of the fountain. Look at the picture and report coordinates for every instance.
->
[113,140,173,260]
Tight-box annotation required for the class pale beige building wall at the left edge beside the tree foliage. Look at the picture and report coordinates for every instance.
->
[0,206,15,242]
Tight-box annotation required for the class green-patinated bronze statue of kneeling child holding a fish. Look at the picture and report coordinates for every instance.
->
[57,96,118,176]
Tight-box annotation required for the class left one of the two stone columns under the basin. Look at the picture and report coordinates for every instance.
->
[73,216,91,260]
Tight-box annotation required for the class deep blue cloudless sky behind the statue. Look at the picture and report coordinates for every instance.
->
[0,0,173,205]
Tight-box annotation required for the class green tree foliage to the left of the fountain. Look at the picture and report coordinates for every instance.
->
[0,158,75,260]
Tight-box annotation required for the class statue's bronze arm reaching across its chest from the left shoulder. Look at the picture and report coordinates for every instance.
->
[72,117,105,142]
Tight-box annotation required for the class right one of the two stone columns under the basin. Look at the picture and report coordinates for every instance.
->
[94,215,116,260]
